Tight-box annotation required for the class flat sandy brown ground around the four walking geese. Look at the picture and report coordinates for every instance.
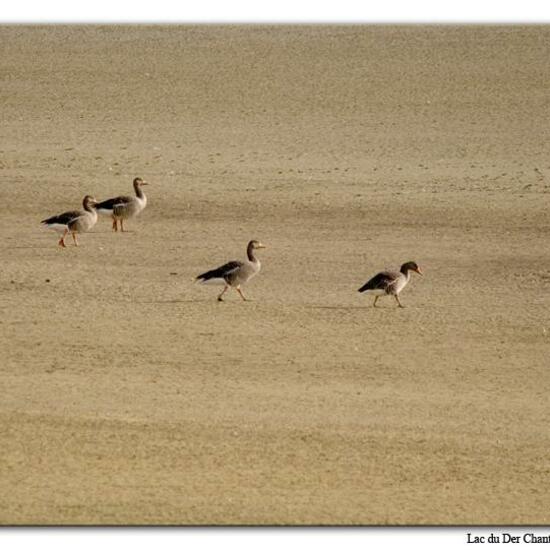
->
[0,26,550,524]
